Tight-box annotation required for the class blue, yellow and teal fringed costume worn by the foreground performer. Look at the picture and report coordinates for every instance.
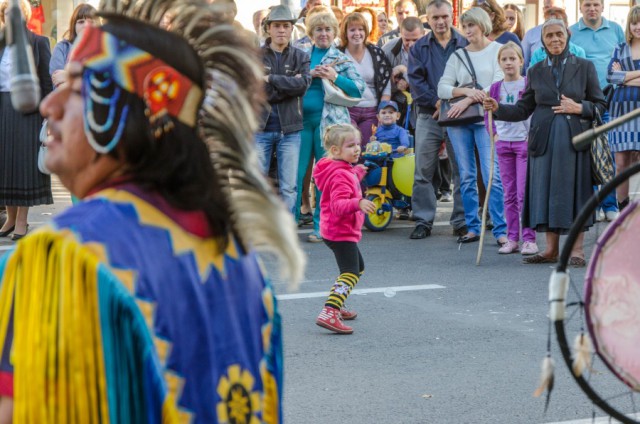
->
[0,184,282,423]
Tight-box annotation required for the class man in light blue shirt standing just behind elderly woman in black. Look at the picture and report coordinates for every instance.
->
[569,0,625,221]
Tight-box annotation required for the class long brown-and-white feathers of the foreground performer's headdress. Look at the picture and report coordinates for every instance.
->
[90,0,305,286]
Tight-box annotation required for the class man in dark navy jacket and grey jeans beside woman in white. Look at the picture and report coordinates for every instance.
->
[409,0,468,239]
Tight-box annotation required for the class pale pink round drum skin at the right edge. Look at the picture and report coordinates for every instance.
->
[584,202,640,392]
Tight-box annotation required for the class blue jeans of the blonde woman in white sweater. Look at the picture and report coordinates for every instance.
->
[447,124,507,239]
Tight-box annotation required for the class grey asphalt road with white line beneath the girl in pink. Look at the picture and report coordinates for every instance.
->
[0,182,636,424]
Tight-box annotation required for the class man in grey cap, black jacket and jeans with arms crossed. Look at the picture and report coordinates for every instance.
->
[256,6,311,217]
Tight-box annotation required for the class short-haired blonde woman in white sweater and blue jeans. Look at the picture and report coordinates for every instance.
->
[438,7,507,245]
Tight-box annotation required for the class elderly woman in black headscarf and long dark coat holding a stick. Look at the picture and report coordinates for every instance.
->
[484,19,605,266]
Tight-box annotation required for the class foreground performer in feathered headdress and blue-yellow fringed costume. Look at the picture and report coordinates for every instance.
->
[0,0,303,423]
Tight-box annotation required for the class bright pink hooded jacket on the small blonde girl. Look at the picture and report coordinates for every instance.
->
[313,158,366,243]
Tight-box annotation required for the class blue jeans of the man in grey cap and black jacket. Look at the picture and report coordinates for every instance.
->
[256,131,300,214]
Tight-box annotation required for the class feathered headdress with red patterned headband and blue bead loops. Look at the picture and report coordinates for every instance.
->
[70,0,305,282]
